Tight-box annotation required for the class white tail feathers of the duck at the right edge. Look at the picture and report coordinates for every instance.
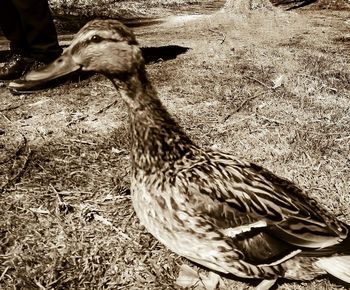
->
[315,256,350,283]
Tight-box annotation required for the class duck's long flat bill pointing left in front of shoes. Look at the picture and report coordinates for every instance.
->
[24,50,81,83]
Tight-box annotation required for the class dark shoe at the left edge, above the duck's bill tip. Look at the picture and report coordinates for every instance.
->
[0,54,35,80]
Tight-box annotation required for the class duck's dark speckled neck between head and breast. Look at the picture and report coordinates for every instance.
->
[112,67,195,172]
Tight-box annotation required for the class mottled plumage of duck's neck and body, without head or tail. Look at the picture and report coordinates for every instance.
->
[118,60,348,280]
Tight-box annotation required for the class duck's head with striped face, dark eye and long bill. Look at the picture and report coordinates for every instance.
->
[25,20,143,81]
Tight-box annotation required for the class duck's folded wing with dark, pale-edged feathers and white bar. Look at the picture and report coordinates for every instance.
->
[180,152,348,250]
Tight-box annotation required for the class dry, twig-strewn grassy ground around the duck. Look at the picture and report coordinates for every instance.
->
[0,1,350,290]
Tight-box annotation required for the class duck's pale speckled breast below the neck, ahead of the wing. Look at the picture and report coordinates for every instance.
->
[131,175,242,274]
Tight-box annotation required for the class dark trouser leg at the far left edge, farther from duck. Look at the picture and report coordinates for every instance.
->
[0,0,29,55]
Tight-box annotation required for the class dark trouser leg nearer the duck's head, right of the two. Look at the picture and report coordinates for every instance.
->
[6,0,62,62]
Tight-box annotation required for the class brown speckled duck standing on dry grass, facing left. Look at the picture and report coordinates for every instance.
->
[26,20,350,289]
